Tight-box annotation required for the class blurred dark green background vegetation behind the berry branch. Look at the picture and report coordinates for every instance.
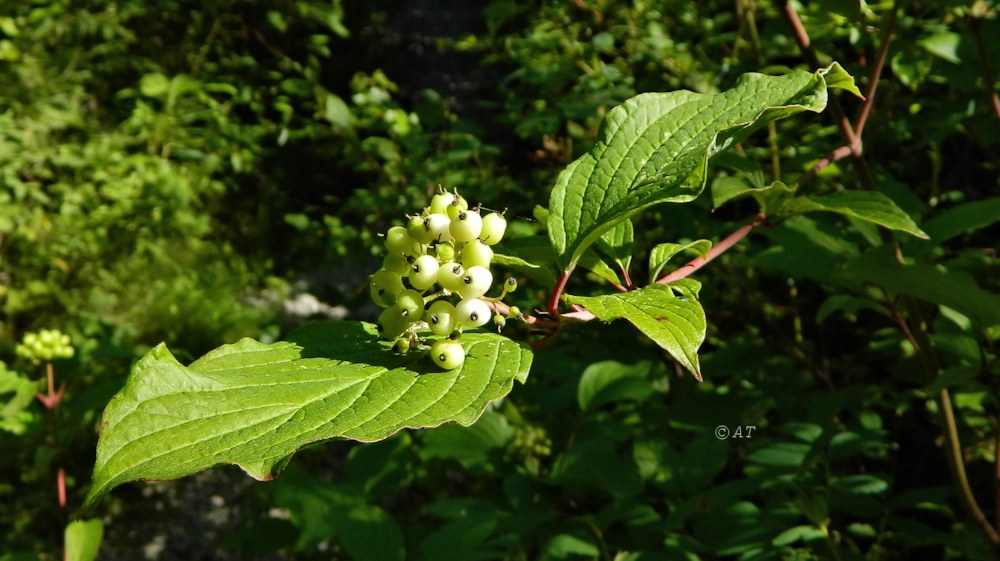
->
[0,0,1000,560]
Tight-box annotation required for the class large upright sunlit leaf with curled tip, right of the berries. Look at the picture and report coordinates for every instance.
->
[548,63,856,270]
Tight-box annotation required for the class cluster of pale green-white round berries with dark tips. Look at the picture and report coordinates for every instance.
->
[370,191,517,370]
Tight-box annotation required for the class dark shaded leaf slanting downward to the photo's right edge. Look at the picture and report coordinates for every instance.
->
[846,248,1000,328]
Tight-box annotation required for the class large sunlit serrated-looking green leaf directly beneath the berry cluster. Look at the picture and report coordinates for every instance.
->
[86,322,532,504]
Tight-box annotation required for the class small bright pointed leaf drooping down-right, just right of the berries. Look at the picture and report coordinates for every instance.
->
[566,279,707,381]
